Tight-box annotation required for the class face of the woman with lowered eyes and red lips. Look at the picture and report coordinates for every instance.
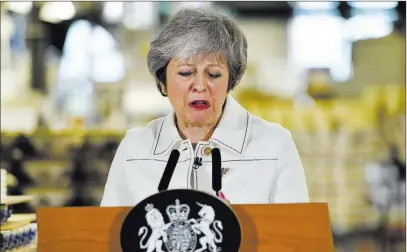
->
[166,56,233,127]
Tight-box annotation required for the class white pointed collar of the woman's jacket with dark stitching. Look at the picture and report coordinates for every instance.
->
[151,95,250,157]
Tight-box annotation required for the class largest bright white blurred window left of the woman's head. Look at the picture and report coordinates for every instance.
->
[56,20,124,116]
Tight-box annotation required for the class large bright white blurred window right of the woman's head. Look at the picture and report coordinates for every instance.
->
[289,14,351,81]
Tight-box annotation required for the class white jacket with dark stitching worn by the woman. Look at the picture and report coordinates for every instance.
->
[101,96,309,206]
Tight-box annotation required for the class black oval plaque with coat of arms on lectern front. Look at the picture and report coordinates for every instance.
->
[120,190,241,252]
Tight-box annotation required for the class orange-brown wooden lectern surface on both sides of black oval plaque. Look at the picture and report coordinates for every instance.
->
[37,203,334,252]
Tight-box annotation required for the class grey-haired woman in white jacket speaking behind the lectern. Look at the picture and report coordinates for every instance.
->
[101,9,308,206]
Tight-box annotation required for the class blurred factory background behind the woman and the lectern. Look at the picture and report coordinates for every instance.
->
[0,1,406,252]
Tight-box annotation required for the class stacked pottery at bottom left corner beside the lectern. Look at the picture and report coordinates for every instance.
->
[0,169,37,252]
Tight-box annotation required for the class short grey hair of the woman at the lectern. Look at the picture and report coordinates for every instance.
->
[147,8,247,96]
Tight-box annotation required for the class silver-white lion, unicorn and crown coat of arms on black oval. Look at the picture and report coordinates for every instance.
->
[138,199,223,252]
